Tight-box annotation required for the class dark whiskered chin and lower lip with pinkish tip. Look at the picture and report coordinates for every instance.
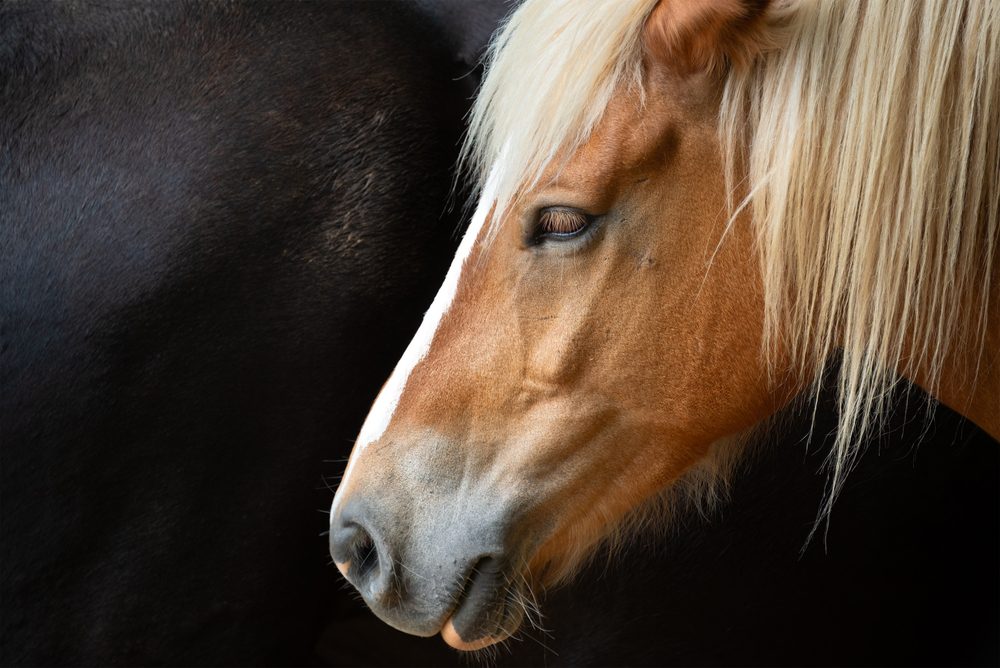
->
[441,558,524,652]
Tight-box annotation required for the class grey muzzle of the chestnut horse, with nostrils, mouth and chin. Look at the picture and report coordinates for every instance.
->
[330,490,525,650]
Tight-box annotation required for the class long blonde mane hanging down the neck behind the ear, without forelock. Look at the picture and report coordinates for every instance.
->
[720,0,1000,513]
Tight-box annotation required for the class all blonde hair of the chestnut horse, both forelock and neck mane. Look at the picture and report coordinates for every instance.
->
[463,0,1000,513]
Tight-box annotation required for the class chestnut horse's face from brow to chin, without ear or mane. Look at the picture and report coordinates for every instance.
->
[331,0,779,649]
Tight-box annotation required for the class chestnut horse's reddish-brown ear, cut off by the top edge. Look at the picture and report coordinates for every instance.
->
[644,0,771,73]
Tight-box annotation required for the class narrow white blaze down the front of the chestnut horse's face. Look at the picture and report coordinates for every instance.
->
[330,168,498,523]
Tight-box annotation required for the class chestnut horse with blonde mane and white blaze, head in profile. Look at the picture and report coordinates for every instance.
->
[330,0,1000,651]
